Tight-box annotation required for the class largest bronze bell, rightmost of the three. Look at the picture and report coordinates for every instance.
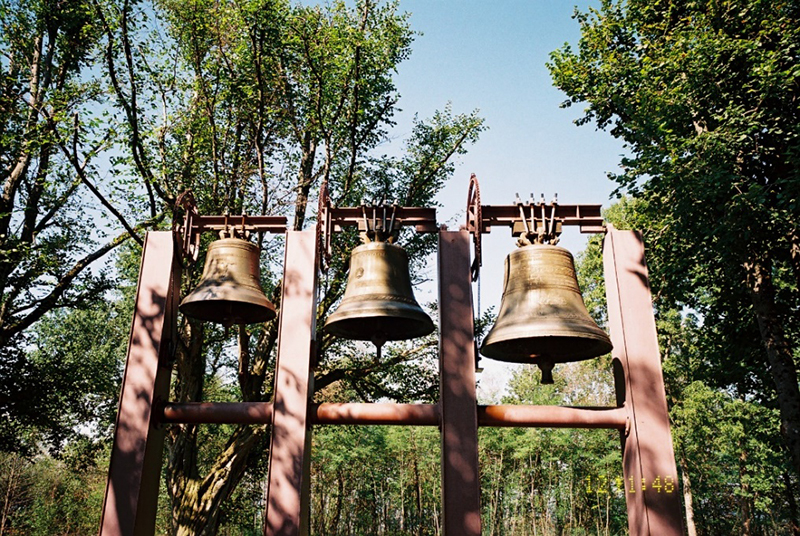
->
[481,244,611,384]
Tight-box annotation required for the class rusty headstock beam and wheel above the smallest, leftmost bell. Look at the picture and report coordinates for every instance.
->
[172,190,286,262]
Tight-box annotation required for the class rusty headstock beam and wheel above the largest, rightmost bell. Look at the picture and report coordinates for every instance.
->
[464,174,606,281]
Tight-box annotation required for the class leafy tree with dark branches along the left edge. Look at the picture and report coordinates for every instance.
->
[0,0,165,450]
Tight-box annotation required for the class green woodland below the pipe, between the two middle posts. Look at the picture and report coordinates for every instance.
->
[311,426,441,536]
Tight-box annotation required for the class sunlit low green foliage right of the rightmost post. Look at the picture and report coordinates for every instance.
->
[671,382,791,534]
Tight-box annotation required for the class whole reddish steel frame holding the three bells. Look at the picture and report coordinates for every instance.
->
[99,182,685,536]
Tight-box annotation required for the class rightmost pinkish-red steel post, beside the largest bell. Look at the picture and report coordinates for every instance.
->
[603,225,684,536]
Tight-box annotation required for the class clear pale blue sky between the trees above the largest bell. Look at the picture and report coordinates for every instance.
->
[382,0,623,388]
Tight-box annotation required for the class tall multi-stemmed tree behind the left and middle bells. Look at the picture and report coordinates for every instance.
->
[86,0,482,534]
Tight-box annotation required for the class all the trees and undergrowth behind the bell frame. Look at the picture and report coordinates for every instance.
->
[0,0,800,536]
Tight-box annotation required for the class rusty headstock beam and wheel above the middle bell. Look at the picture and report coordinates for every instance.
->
[317,181,439,269]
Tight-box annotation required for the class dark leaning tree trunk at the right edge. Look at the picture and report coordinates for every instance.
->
[744,255,800,474]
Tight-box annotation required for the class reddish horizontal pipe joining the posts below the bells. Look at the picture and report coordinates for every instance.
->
[162,402,628,430]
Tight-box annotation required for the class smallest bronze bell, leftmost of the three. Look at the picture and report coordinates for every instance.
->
[179,238,275,326]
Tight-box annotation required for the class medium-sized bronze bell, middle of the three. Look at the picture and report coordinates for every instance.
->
[325,242,433,350]
